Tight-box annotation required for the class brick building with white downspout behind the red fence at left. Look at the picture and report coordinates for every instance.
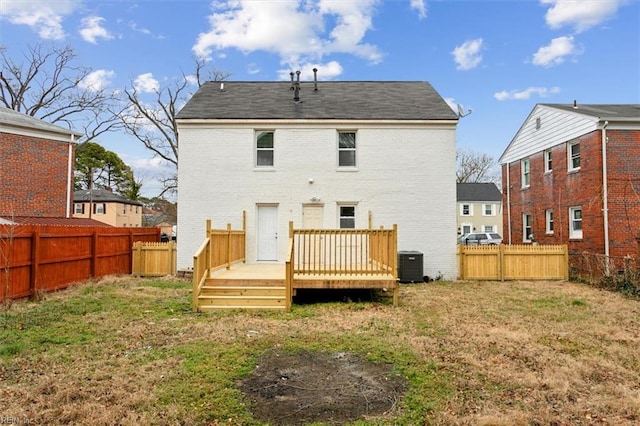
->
[0,108,80,220]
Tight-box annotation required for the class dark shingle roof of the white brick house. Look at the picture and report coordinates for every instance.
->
[177,81,458,120]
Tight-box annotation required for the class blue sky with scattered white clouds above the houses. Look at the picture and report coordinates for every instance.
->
[0,0,640,195]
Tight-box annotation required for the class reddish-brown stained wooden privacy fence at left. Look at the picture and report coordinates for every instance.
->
[0,225,160,301]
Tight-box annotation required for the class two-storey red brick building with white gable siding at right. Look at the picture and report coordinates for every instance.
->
[500,104,640,256]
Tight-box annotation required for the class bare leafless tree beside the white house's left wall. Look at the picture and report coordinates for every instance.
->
[120,59,229,197]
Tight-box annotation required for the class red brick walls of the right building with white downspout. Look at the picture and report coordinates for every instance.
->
[502,130,640,256]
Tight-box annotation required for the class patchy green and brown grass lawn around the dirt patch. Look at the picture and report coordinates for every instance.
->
[0,277,640,425]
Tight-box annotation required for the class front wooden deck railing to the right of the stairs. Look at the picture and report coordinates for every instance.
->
[289,222,398,277]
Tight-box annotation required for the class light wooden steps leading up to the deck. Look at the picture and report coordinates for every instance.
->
[198,278,287,312]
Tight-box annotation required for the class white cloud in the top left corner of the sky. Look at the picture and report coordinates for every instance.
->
[0,0,81,40]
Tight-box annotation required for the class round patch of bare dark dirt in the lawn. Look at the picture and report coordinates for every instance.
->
[240,351,407,425]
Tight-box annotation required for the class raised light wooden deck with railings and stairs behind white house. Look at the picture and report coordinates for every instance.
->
[193,218,399,311]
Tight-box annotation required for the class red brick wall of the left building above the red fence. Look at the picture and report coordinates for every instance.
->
[0,133,73,217]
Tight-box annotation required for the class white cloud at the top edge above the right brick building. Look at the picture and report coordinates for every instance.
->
[540,0,622,32]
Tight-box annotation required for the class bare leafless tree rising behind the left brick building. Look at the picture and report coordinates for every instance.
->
[0,44,121,142]
